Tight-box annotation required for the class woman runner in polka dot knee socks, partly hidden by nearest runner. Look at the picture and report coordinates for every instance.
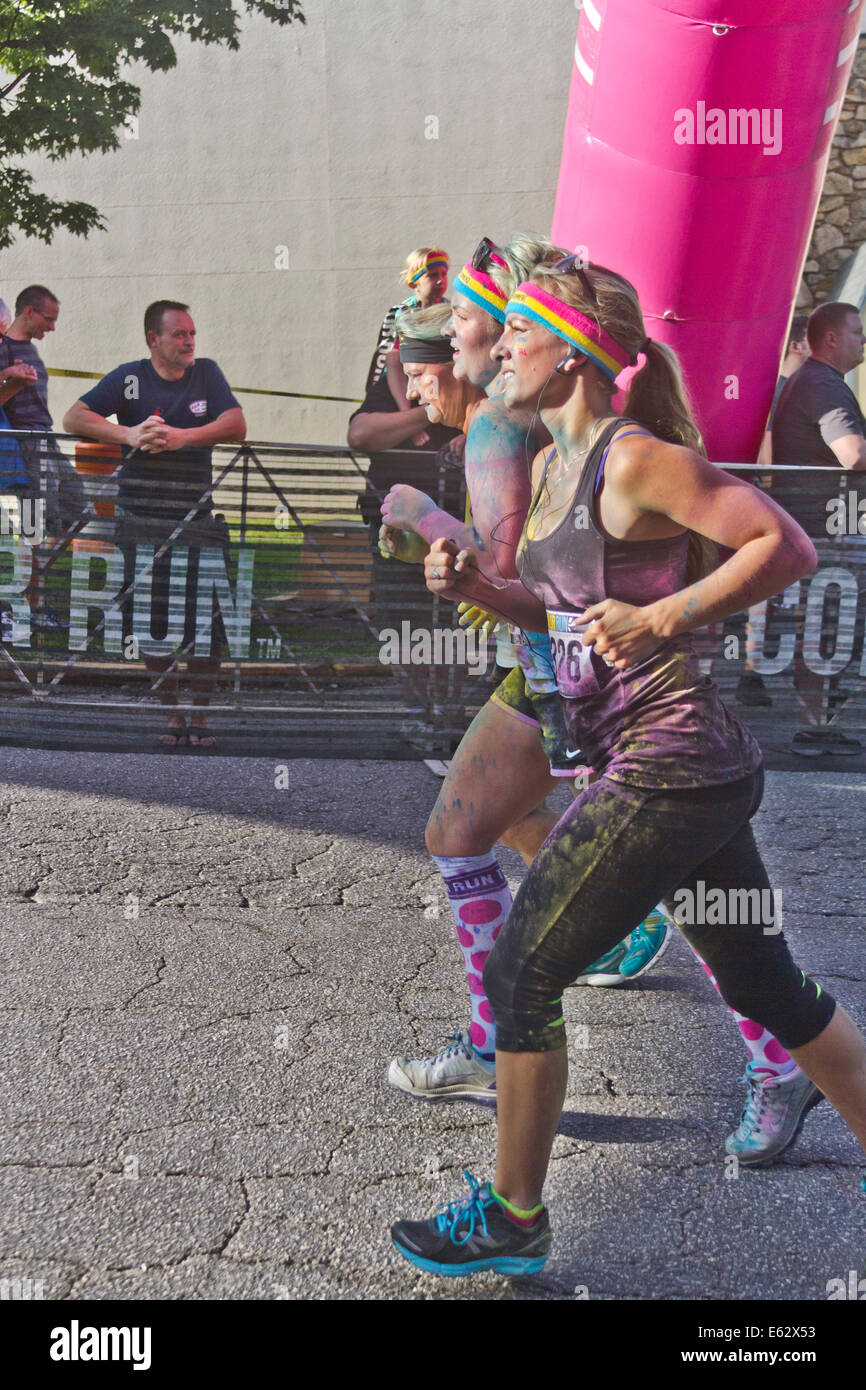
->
[382,238,669,1102]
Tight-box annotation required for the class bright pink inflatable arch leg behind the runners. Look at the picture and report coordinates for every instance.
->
[552,0,862,463]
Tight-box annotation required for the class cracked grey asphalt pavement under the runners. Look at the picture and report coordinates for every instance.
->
[0,748,866,1300]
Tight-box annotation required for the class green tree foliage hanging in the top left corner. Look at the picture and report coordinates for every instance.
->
[0,0,304,247]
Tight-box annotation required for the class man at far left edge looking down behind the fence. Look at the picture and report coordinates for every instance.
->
[0,285,86,628]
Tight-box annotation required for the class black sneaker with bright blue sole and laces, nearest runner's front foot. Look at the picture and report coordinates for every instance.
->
[391,1169,552,1276]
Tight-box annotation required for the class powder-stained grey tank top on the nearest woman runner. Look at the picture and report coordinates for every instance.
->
[517,417,762,788]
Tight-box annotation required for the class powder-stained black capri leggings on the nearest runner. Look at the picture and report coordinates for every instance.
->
[484,770,835,1052]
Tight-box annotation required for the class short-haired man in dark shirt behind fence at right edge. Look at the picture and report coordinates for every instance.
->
[773,303,866,758]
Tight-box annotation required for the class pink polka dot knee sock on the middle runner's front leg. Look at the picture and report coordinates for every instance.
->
[434,853,512,1062]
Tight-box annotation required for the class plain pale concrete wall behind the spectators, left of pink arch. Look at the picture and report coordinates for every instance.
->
[0,0,578,443]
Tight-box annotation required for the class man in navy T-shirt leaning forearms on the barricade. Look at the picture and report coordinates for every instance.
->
[64,299,246,748]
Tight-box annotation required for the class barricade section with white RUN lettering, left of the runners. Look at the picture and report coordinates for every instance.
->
[0,432,480,758]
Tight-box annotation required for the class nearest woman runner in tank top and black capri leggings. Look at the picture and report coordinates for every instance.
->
[392,257,866,1275]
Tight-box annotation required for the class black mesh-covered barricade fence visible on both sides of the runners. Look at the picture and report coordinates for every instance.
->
[0,432,866,770]
